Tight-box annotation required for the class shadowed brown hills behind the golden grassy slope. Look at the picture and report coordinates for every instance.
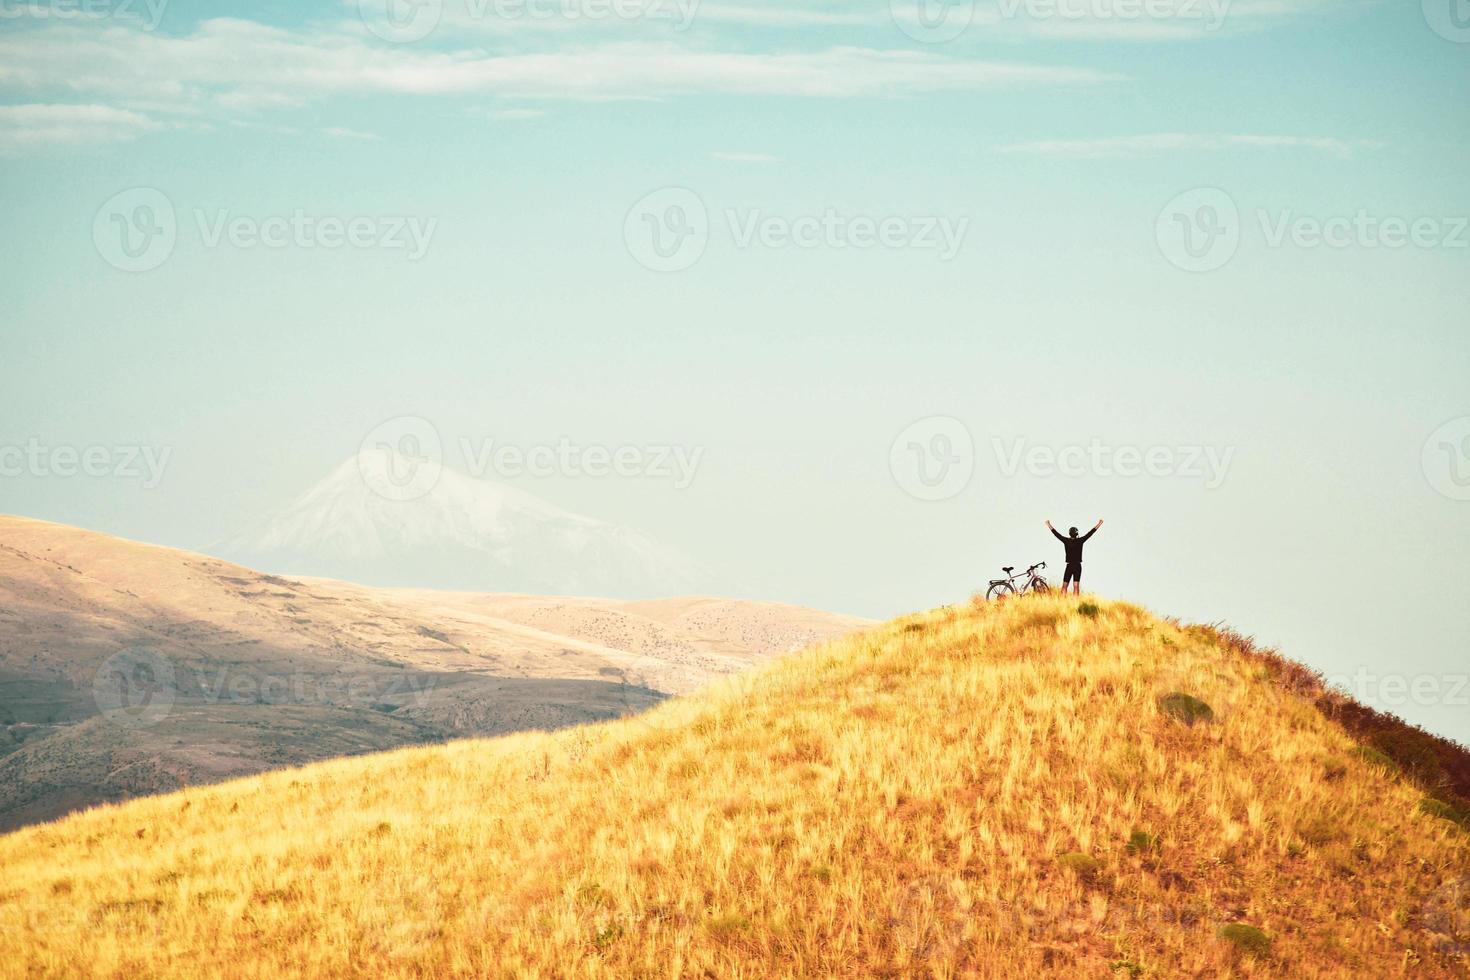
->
[0,516,867,830]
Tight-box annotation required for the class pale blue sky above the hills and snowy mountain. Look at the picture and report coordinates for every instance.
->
[0,0,1470,739]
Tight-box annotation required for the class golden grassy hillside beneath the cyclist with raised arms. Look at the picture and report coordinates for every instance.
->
[0,598,1470,979]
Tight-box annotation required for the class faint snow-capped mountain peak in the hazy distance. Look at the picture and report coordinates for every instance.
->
[206,454,716,598]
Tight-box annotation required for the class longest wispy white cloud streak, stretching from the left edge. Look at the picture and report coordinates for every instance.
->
[0,19,1110,112]
